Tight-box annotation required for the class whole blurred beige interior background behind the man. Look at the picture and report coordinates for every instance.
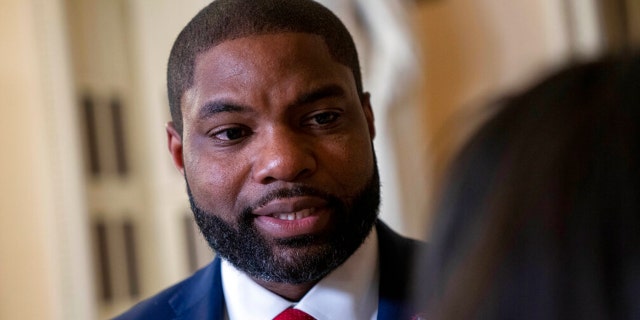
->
[0,0,640,319]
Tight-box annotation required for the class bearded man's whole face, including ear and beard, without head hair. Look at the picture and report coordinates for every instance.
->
[167,33,379,283]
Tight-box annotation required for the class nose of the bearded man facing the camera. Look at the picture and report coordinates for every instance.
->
[253,128,317,184]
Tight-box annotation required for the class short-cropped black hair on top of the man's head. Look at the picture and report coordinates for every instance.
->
[167,0,363,133]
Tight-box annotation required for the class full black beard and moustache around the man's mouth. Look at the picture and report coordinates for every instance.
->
[187,164,380,284]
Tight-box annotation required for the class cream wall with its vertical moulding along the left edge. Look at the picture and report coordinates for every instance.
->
[0,0,94,319]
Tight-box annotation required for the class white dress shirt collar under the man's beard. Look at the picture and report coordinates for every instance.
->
[221,228,379,320]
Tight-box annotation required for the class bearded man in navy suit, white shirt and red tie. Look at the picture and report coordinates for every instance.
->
[115,0,419,319]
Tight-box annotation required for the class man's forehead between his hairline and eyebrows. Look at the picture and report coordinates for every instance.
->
[182,33,357,112]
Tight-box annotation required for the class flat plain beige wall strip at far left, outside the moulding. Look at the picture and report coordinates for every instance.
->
[0,1,57,319]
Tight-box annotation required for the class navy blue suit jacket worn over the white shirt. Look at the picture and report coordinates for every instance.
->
[116,221,424,320]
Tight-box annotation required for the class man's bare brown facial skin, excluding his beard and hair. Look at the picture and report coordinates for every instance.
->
[167,33,375,301]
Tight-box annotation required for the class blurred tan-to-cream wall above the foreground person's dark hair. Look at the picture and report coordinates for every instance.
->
[416,0,598,231]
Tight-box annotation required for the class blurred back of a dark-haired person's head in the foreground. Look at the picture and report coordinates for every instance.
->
[415,56,640,319]
